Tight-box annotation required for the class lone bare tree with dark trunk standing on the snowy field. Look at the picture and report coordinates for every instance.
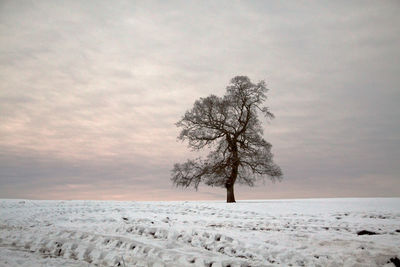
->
[171,76,282,202]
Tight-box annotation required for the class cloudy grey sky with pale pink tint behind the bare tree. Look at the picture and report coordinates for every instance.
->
[0,0,400,200]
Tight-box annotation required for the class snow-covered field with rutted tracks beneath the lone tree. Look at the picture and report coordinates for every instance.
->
[0,198,400,266]
